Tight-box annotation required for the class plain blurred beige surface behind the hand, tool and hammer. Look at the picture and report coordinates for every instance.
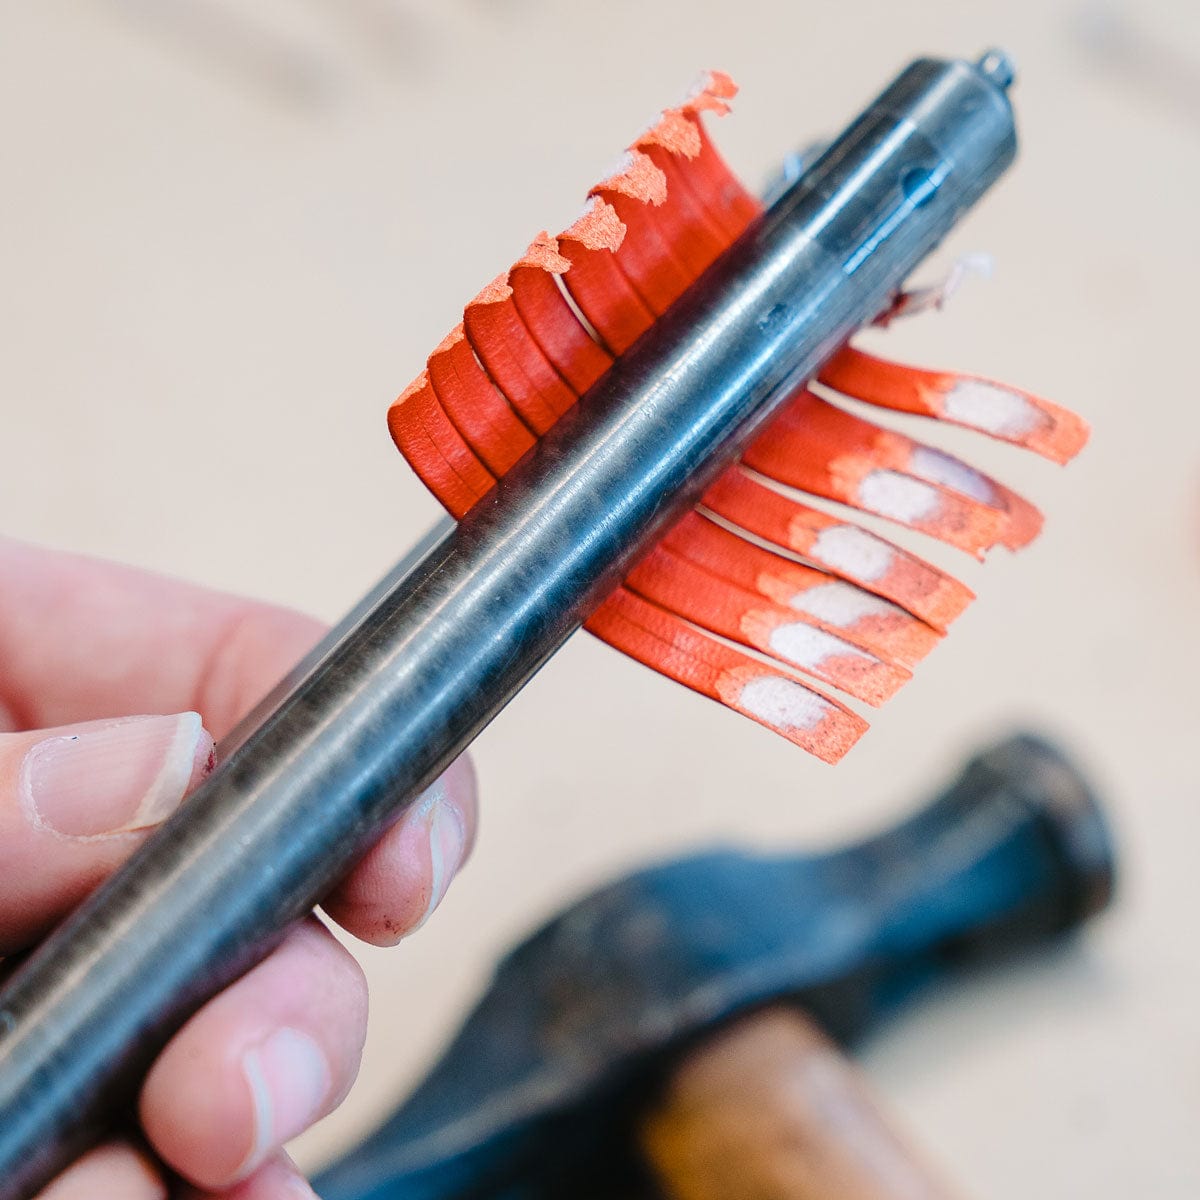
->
[0,0,1200,1200]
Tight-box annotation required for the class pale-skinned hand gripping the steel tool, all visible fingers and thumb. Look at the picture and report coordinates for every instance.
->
[0,539,476,1200]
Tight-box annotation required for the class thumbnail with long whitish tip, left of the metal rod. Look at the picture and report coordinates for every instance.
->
[20,713,212,839]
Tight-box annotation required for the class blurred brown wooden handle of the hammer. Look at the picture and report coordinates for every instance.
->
[640,1007,952,1200]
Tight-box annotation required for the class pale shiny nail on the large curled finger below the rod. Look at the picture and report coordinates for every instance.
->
[241,1027,332,1166]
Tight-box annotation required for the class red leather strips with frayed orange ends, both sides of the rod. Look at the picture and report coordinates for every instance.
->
[388,72,1087,762]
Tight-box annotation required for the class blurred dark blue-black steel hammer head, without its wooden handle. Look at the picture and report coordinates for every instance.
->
[316,736,1114,1200]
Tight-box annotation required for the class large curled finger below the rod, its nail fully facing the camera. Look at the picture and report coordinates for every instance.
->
[139,919,367,1192]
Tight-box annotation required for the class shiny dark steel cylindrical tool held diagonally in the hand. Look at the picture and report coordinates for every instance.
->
[0,53,1015,1200]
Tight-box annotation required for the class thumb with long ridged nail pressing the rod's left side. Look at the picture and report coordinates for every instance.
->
[0,713,212,955]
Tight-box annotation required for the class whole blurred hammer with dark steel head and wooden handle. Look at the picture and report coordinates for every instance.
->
[314,736,1114,1200]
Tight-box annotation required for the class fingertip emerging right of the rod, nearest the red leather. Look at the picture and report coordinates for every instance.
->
[322,756,478,946]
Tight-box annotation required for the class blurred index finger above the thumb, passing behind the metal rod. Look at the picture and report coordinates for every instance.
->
[0,539,322,738]
